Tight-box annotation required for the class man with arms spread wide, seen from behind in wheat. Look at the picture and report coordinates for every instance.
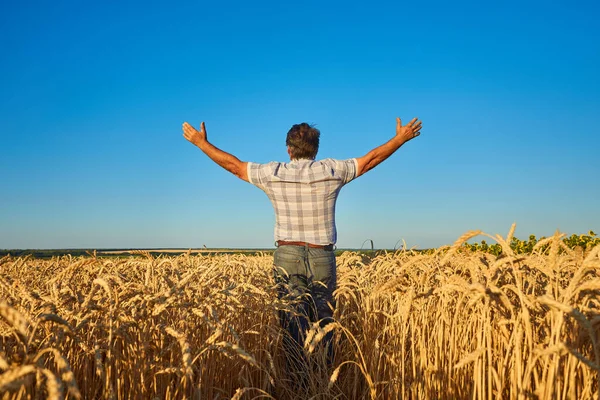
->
[183,118,421,379]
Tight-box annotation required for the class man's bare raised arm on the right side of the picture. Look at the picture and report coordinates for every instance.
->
[356,118,422,177]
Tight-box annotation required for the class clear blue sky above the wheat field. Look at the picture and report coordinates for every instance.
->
[0,1,600,248]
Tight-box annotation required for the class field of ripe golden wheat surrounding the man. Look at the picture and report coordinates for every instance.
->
[0,233,600,399]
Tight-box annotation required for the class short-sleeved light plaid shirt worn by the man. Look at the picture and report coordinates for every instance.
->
[248,158,358,245]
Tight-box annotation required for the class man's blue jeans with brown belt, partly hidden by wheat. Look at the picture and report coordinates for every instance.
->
[273,245,337,374]
